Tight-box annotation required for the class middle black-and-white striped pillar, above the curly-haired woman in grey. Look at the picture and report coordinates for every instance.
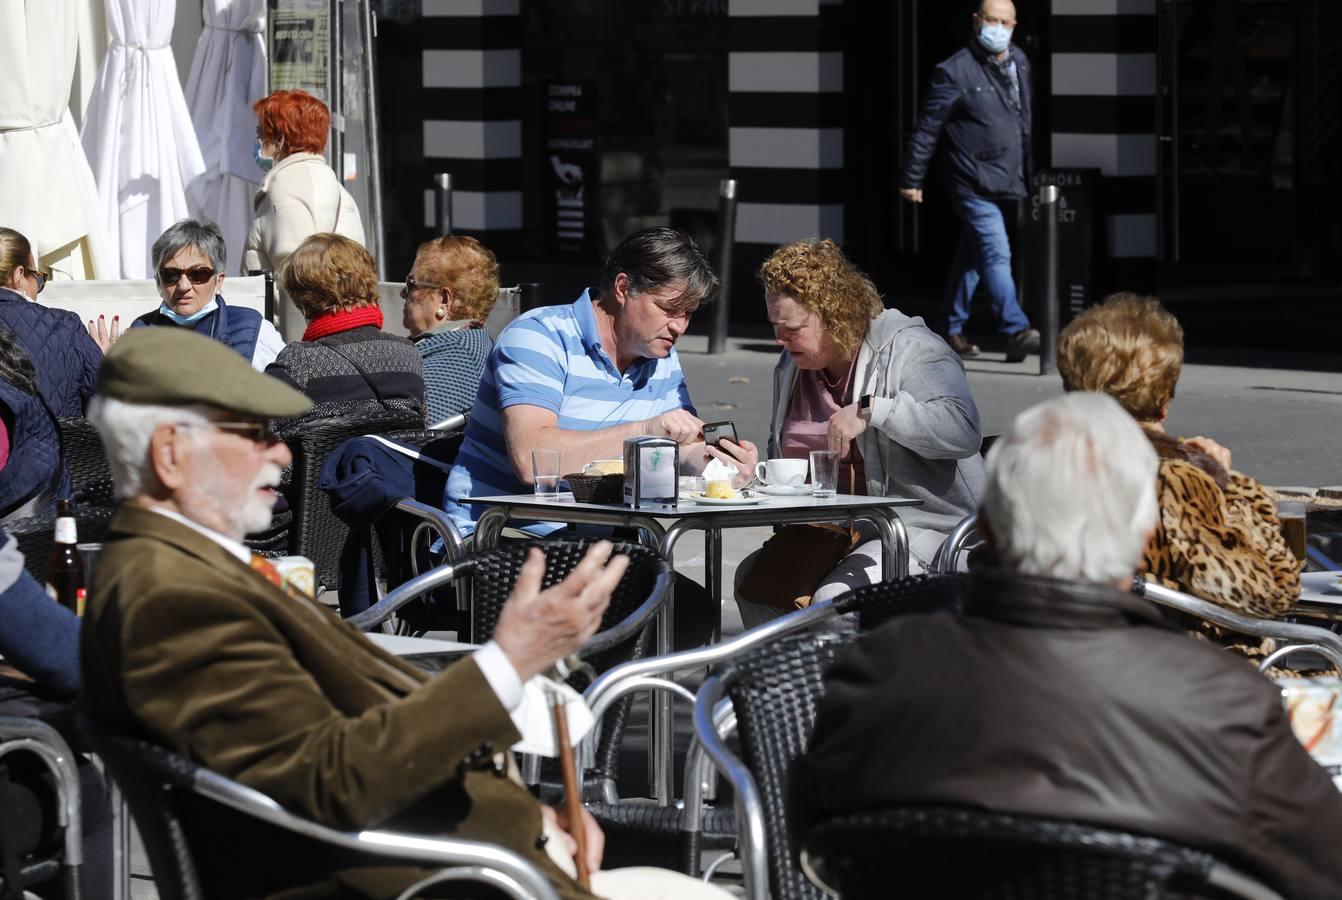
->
[727,0,844,283]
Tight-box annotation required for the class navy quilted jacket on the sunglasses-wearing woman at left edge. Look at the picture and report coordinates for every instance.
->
[0,287,102,418]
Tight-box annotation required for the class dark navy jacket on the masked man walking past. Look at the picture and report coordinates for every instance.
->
[902,40,1032,197]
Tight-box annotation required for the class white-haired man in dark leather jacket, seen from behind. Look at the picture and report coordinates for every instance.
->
[790,393,1342,899]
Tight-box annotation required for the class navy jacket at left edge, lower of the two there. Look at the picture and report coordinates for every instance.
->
[0,380,70,520]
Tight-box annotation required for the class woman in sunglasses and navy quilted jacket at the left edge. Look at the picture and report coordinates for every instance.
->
[0,228,102,417]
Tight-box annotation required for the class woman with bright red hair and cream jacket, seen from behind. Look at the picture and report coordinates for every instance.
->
[243,91,364,333]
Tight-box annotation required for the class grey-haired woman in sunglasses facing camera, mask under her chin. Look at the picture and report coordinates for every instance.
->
[124,219,285,372]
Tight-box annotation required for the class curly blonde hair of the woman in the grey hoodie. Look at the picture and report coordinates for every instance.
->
[756,237,884,354]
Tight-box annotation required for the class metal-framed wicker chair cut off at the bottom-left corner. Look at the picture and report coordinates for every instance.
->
[0,716,83,897]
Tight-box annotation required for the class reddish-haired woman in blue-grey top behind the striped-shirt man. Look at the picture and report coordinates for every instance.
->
[401,235,499,423]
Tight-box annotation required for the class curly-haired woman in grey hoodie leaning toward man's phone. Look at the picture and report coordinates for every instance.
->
[738,240,984,626]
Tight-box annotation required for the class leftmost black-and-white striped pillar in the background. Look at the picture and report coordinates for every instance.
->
[421,0,522,254]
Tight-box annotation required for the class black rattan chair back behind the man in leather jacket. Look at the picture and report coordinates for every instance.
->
[801,806,1280,900]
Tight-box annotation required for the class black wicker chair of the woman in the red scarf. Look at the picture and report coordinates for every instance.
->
[259,409,424,593]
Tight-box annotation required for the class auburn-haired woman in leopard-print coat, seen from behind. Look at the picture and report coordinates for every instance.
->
[1057,292,1300,618]
